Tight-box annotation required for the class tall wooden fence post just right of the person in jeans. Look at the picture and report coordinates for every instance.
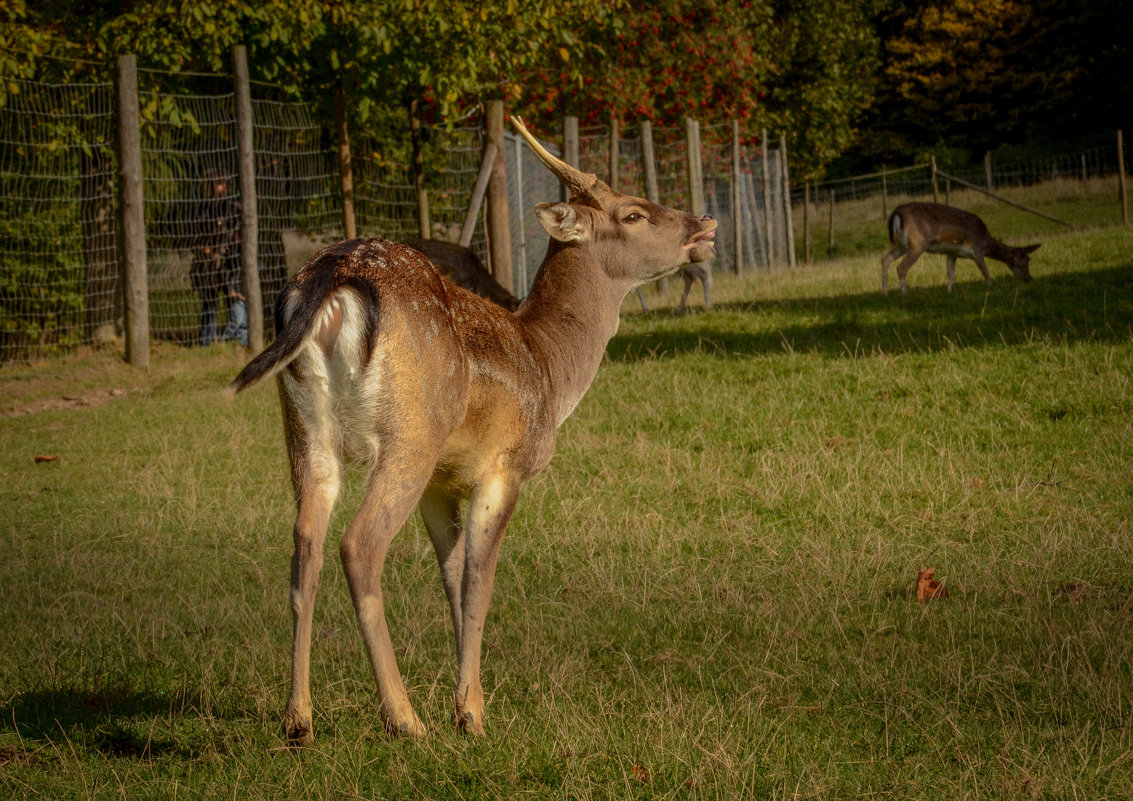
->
[232,44,264,356]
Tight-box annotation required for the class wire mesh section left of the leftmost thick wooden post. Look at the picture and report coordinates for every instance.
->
[0,79,121,361]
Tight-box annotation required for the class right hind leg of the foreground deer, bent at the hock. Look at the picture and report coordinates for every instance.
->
[339,443,438,736]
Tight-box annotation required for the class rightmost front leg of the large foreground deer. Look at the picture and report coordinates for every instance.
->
[454,476,519,736]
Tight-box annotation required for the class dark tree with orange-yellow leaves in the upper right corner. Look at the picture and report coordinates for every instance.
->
[846,0,1133,170]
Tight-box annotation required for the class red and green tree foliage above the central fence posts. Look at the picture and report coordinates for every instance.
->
[512,0,877,179]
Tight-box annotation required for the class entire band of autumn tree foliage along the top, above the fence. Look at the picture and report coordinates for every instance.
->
[0,0,1133,177]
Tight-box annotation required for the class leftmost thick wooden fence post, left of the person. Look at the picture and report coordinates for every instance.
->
[117,56,150,369]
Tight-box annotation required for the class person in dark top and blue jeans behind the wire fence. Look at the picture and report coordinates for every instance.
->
[189,173,248,347]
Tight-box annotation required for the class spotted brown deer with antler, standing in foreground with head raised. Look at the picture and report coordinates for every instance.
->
[229,118,716,744]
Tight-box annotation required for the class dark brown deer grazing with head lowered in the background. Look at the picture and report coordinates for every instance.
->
[881,203,1039,295]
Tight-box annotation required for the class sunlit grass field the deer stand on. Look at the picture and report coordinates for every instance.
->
[0,222,1133,799]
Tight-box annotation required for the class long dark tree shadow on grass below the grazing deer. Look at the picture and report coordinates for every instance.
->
[608,263,1133,361]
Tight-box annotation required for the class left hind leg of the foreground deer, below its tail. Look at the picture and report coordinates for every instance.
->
[283,451,340,747]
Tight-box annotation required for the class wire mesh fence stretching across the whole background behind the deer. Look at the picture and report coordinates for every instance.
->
[0,50,1117,363]
